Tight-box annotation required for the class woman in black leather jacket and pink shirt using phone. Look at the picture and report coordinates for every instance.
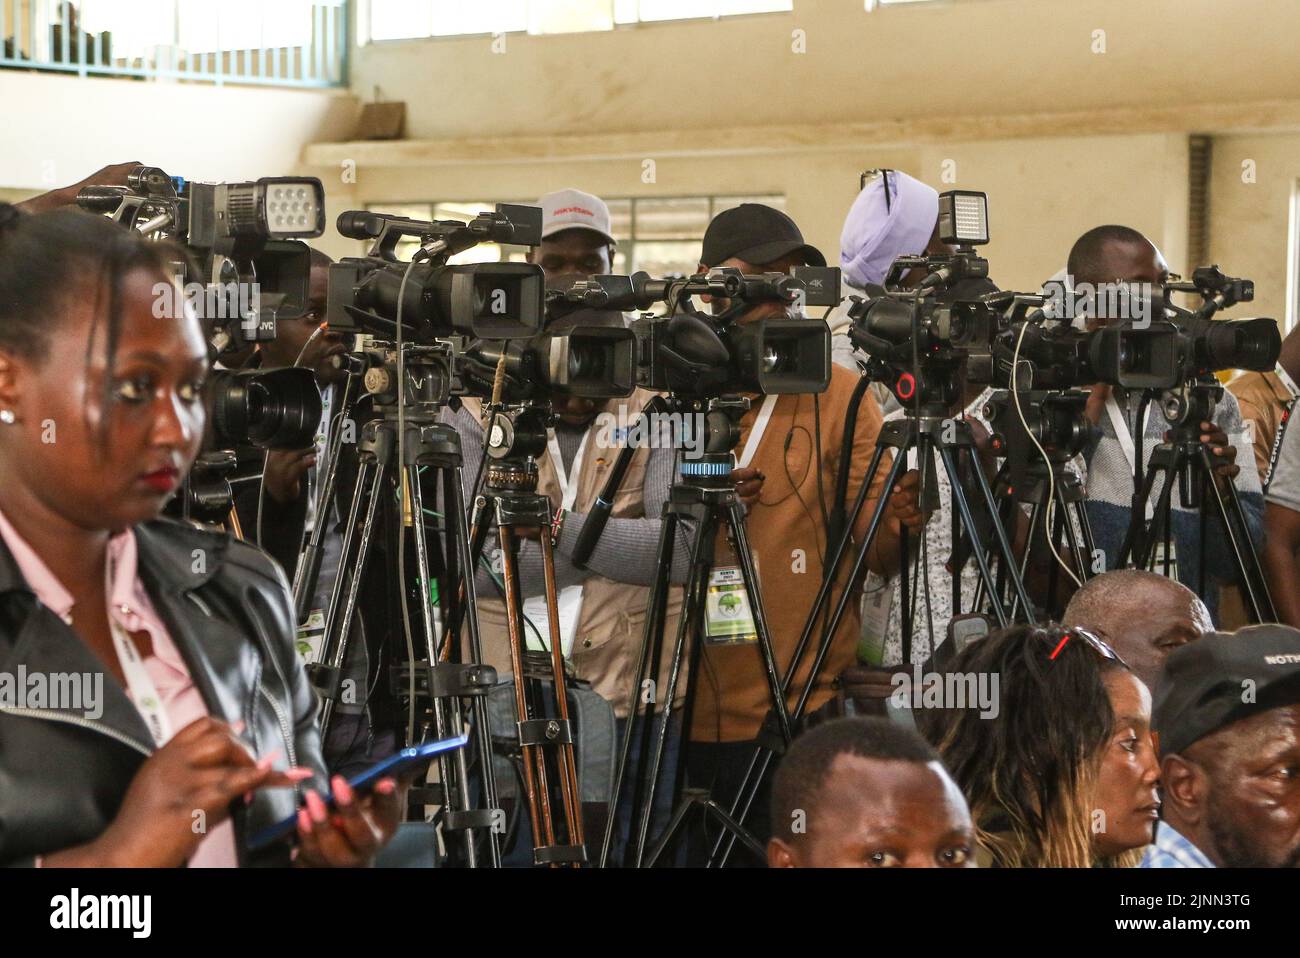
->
[0,204,400,867]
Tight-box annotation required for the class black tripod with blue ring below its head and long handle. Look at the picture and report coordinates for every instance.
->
[585,395,792,867]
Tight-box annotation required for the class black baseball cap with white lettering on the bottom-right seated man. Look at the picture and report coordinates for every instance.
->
[1152,625,1300,755]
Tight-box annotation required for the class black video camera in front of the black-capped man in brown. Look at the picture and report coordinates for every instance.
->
[551,266,840,398]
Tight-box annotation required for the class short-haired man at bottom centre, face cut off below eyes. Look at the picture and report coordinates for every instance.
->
[767,719,975,868]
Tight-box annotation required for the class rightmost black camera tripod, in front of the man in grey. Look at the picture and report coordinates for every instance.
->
[1119,380,1277,623]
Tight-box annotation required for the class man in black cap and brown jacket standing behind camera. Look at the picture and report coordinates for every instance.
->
[688,203,924,838]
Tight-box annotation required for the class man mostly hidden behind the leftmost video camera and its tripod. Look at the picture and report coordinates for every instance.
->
[235,250,402,775]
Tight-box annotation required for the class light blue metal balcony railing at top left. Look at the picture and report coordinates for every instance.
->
[0,0,351,87]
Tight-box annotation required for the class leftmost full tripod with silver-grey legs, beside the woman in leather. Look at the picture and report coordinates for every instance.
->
[294,344,503,867]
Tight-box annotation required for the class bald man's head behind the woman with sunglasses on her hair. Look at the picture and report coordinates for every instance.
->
[1062,569,1214,689]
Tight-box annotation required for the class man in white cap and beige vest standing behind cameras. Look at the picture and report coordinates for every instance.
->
[443,190,692,861]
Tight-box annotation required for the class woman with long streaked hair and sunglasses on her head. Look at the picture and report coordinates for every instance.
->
[918,625,1160,868]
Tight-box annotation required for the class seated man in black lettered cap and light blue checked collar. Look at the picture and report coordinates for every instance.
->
[1141,625,1300,868]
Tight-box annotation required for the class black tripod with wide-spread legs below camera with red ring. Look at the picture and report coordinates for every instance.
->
[709,372,1036,867]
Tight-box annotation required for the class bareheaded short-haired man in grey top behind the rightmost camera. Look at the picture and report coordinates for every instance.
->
[1069,226,1264,621]
